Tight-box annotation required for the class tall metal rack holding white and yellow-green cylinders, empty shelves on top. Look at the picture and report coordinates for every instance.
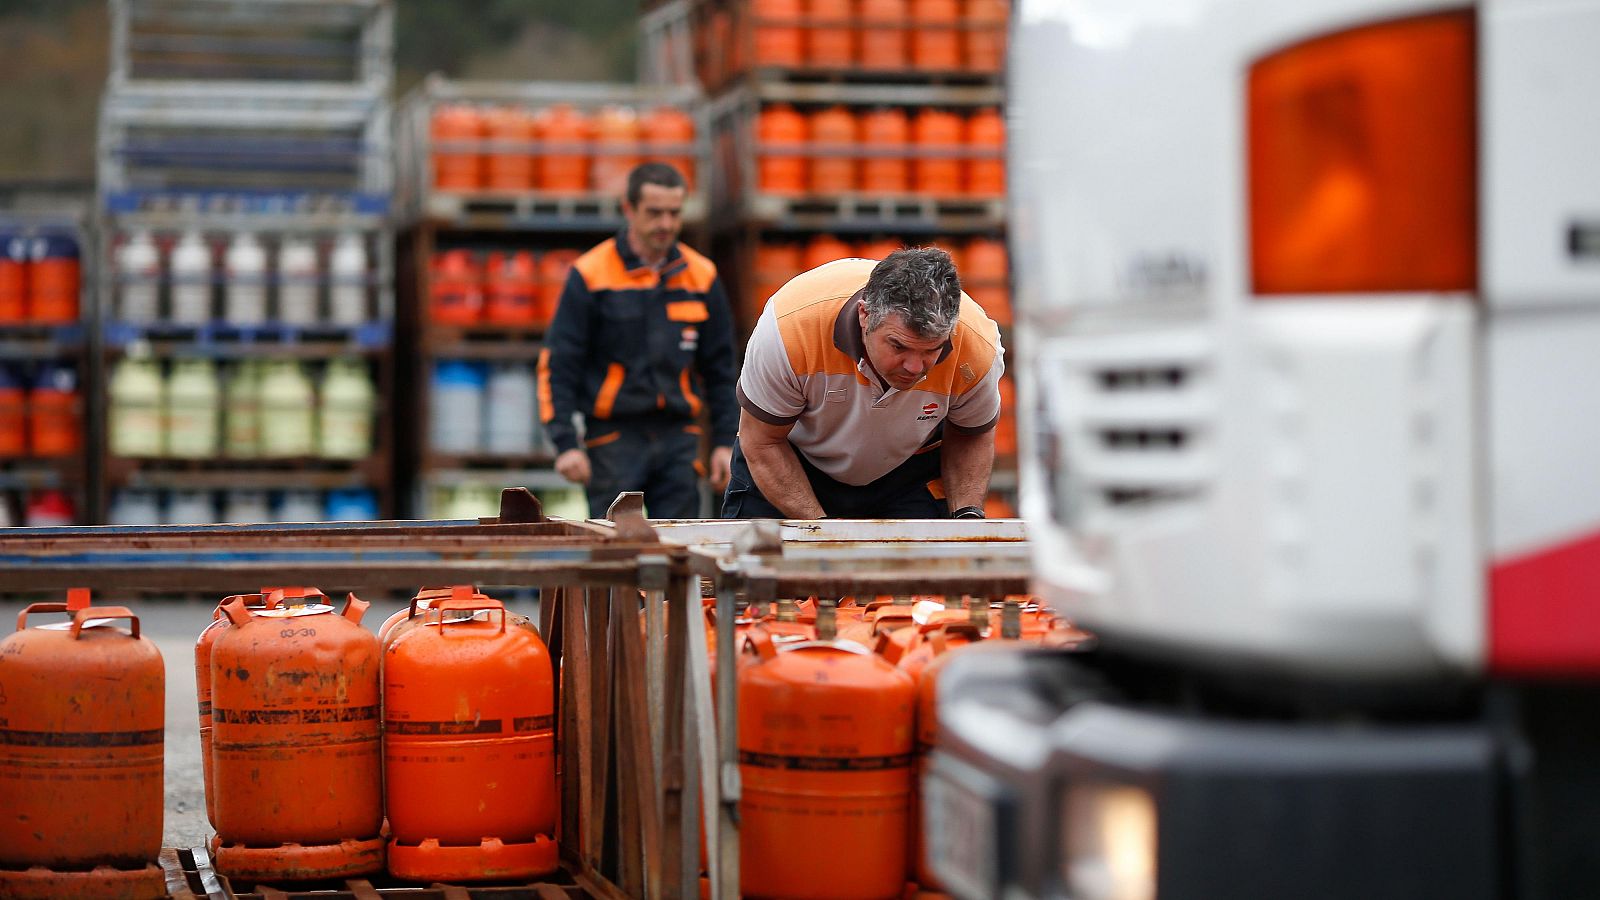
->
[93,0,395,520]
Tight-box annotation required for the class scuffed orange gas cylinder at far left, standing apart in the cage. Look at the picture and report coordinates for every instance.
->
[0,589,166,900]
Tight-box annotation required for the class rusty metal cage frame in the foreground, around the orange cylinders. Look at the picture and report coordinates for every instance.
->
[0,490,1029,900]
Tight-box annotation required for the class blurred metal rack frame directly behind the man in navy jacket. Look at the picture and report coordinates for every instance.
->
[395,75,709,514]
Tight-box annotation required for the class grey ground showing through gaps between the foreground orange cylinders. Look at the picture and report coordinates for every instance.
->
[0,591,538,847]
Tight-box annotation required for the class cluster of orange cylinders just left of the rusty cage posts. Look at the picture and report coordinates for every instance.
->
[195,586,558,881]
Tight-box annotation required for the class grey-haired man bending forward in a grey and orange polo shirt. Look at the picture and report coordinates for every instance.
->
[722,247,1005,519]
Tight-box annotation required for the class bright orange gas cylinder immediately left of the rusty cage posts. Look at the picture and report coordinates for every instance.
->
[384,588,560,881]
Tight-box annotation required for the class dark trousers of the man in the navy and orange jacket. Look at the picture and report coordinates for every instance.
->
[584,420,701,519]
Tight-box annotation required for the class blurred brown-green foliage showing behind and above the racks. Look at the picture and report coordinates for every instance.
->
[0,0,638,184]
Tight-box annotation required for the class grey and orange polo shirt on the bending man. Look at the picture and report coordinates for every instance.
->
[738,259,1005,485]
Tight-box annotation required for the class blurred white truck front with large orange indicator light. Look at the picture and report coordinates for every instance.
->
[926,0,1600,900]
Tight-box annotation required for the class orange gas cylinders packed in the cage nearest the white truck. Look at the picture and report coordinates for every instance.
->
[723,597,1086,898]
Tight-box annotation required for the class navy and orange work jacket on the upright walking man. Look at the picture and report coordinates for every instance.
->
[539,229,739,452]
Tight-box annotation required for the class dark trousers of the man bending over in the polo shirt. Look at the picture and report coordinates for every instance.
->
[722,440,950,519]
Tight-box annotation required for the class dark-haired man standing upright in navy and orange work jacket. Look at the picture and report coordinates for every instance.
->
[539,162,738,519]
